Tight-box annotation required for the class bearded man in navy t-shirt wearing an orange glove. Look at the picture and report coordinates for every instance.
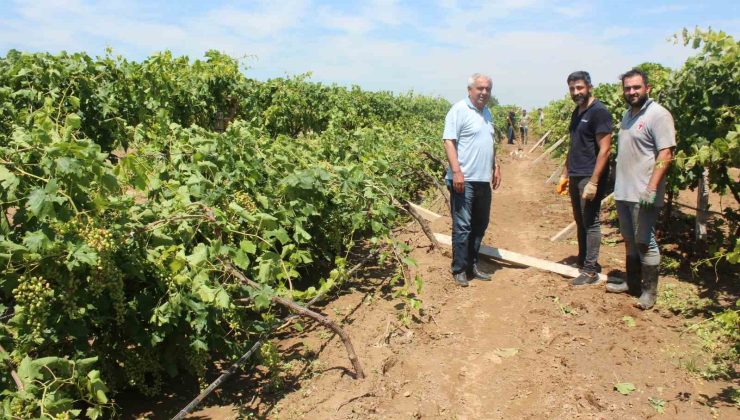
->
[556,71,613,286]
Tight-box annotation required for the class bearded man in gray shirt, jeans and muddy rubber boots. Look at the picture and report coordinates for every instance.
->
[606,69,676,309]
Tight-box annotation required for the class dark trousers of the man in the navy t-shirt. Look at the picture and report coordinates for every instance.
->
[568,176,606,273]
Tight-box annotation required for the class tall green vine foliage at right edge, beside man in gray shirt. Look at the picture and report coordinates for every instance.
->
[664,29,740,197]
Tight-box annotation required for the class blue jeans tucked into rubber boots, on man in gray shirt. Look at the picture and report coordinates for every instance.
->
[617,201,660,265]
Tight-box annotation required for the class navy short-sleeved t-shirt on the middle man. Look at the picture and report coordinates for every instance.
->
[568,99,612,177]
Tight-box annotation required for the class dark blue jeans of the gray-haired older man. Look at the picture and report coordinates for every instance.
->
[447,180,491,274]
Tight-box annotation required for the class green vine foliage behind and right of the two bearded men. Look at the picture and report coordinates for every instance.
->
[544,29,740,264]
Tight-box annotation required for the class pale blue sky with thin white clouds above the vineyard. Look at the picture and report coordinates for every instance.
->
[0,0,740,107]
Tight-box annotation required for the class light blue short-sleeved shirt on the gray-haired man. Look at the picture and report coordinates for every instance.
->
[442,98,494,182]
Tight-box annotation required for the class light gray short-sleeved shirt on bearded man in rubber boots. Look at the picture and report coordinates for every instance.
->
[614,99,676,207]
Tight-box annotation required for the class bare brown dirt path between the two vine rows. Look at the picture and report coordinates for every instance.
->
[189,146,738,419]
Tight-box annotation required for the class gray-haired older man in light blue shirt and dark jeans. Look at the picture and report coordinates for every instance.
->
[442,73,501,287]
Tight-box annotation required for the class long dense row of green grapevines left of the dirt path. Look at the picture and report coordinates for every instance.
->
[0,51,449,418]
